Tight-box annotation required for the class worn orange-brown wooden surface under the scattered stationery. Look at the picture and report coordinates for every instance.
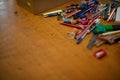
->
[0,0,120,80]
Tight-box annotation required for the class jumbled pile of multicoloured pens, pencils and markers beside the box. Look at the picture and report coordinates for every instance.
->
[43,0,120,56]
